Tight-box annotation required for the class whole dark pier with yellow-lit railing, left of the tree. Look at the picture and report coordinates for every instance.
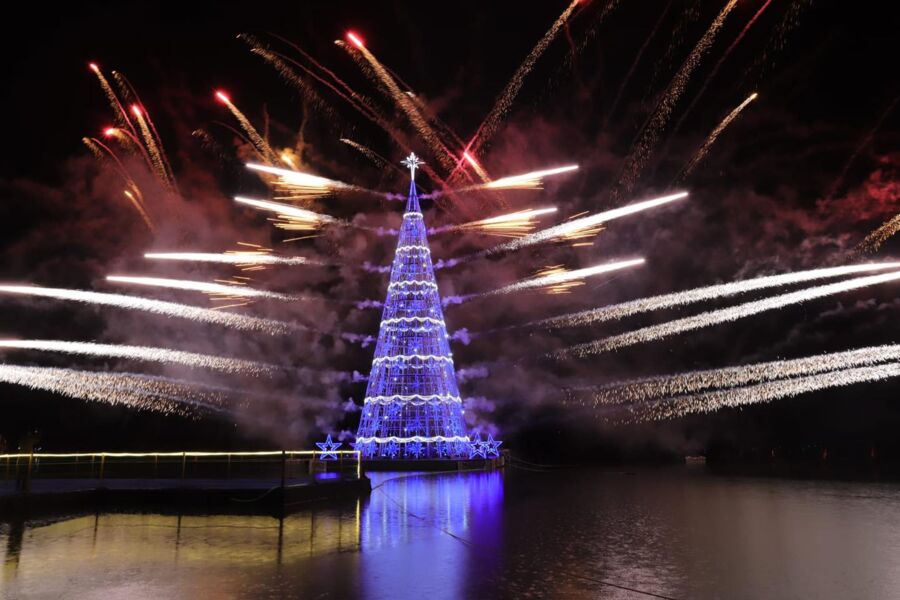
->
[0,450,371,517]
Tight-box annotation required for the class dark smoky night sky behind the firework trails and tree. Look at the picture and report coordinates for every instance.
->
[0,0,900,458]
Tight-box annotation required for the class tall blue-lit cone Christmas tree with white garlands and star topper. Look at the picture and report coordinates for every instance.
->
[355,154,474,459]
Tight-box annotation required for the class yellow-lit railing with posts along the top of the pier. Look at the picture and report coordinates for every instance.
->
[0,450,362,491]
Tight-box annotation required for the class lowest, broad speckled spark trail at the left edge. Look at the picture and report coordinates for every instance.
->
[0,365,222,416]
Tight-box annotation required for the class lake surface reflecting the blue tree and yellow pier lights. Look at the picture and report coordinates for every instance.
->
[0,468,900,600]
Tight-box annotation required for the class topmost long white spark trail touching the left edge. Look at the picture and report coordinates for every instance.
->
[0,285,296,335]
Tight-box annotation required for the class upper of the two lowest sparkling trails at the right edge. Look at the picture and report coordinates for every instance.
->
[571,344,900,406]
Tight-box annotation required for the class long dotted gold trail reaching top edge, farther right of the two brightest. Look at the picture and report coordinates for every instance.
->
[619,0,738,193]
